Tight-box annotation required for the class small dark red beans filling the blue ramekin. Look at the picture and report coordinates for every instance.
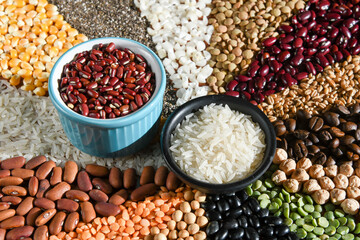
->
[59,43,156,119]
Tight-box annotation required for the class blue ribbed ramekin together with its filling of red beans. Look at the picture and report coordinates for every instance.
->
[48,37,166,158]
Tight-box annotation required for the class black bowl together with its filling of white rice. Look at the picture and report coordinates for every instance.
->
[160,95,276,193]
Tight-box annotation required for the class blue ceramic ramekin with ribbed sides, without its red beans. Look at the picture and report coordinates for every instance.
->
[49,37,166,157]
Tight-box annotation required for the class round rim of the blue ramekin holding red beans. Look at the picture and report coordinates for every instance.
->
[48,37,166,128]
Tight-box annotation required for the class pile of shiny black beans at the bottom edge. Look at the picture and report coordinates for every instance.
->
[204,190,298,240]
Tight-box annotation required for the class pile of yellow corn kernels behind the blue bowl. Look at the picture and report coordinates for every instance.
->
[0,0,87,96]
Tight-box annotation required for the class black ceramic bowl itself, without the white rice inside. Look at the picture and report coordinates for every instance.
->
[160,95,276,193]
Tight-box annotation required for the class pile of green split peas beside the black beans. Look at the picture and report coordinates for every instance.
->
[246,174,360,240]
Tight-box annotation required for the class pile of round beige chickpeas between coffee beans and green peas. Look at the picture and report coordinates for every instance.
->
[272,148,360,215]
